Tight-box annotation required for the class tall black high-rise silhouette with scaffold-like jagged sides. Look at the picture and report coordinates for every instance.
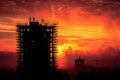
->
[17,18,57,80]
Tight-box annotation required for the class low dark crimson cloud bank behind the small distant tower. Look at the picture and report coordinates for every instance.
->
[59,47,120,70]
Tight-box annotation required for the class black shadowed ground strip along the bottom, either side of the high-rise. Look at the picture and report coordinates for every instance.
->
[0,69,120,80]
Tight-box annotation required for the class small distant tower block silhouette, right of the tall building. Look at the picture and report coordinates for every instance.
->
[75,58,85,73]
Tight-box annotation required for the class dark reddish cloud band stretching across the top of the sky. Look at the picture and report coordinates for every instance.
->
[0,0,120,18]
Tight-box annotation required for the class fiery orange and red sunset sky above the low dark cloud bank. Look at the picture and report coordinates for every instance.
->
[0,0,120,68]
